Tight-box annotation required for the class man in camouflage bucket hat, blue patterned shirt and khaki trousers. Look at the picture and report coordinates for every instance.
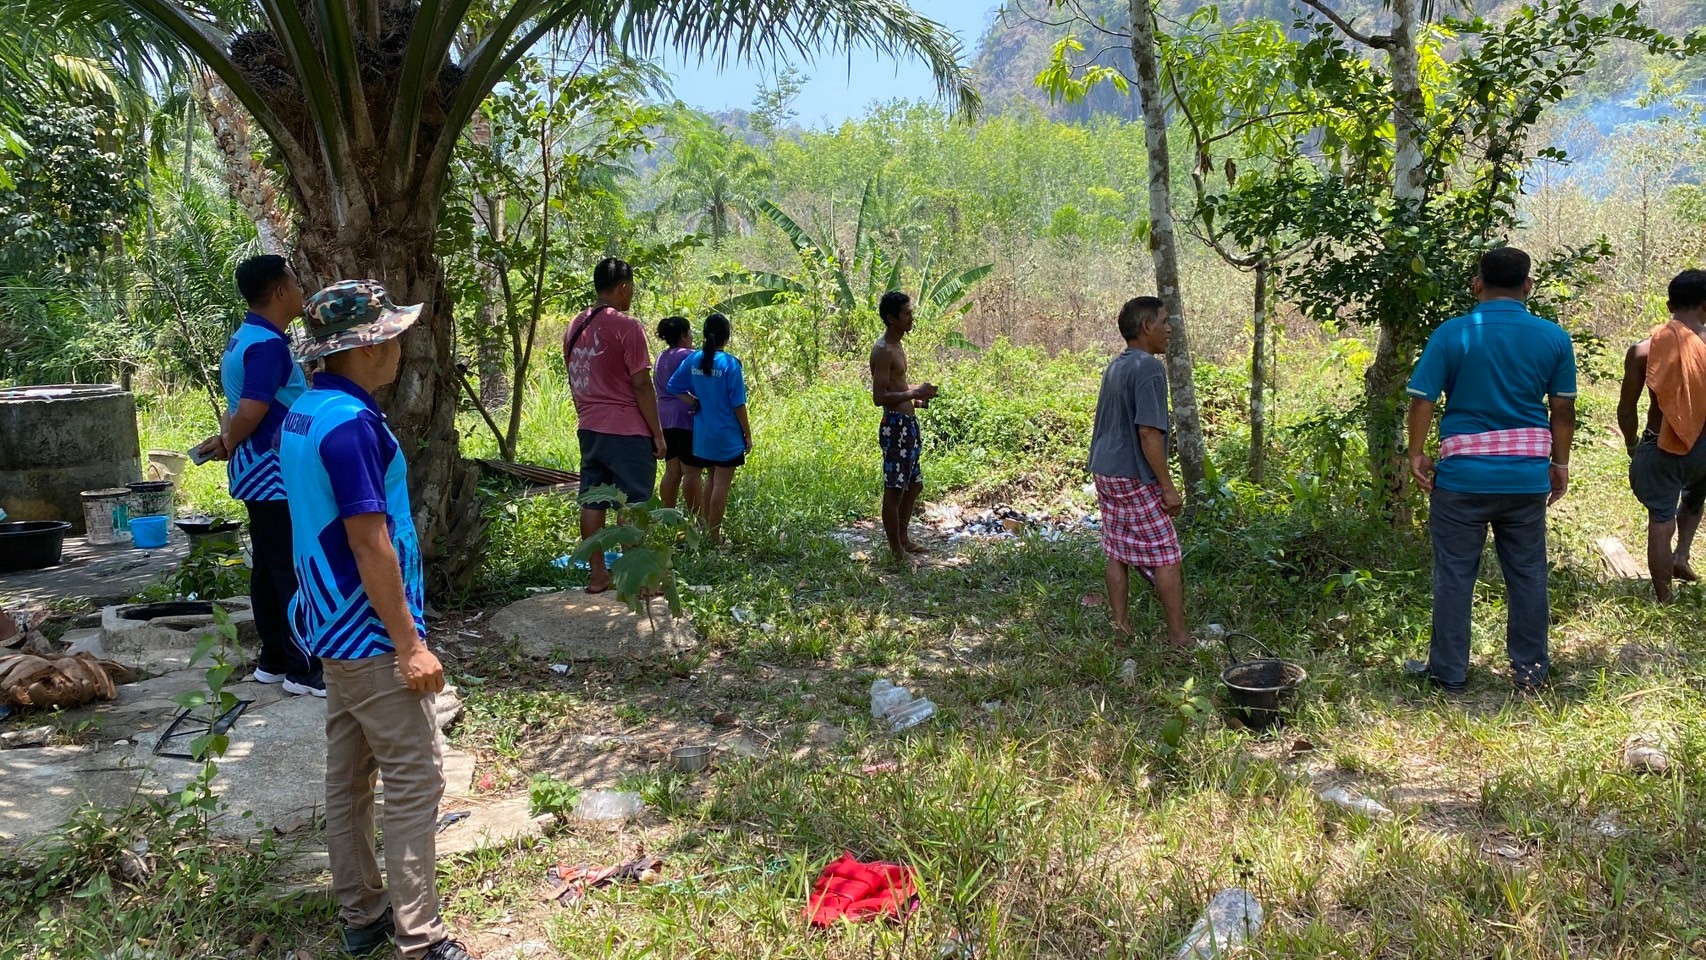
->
[280,280,469,960]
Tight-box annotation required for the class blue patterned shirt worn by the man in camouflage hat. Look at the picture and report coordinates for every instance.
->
[278,373,427,660]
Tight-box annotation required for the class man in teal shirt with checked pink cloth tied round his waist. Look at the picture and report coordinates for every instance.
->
[1406,247,1576,694]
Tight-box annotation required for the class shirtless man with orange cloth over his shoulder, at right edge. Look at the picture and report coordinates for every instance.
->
[1617,269,1706,602]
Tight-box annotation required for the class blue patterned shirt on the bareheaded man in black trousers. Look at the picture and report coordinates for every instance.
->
[218,314,309,500]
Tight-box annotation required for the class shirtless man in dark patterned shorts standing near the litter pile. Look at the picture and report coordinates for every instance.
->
[870,290,937,566]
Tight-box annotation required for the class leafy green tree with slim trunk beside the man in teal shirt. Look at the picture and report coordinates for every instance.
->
[1293,0,1678,520]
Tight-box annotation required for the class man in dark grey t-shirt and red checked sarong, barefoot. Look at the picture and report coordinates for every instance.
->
[1090,297,1191,648]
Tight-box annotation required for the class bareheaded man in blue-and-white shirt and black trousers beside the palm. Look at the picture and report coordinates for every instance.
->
[201,256,326,697]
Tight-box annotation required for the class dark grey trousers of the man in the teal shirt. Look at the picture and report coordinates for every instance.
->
[1428,488,1551,684]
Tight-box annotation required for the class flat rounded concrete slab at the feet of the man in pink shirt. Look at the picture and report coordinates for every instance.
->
[488,590,698,662]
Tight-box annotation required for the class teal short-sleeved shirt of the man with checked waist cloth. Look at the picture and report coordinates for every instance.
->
[1409,300,1576,493]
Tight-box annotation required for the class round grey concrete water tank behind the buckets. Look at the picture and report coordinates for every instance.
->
[0,384,142,534]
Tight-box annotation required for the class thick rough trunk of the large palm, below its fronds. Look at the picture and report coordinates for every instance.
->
[297,218,486,595]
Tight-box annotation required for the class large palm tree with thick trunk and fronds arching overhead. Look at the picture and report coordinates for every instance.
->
[53,0,976,592]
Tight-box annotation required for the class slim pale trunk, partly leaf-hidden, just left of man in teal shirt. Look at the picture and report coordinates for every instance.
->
[1363,0,1426,518]
